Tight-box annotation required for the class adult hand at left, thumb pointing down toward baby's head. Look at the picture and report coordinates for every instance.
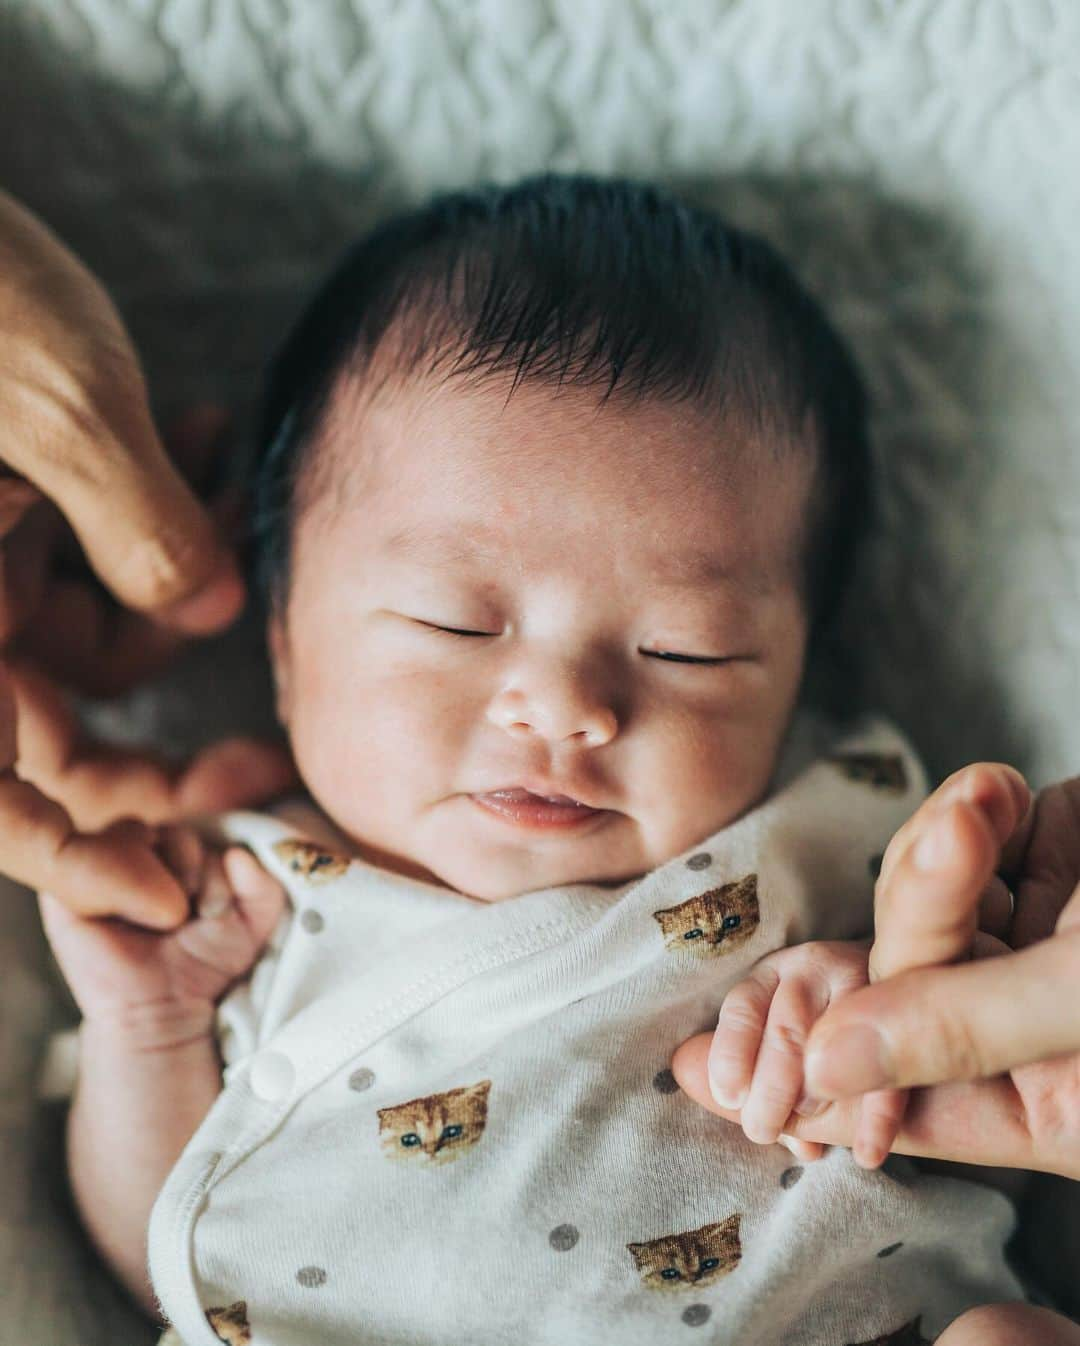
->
[0,194,292,925]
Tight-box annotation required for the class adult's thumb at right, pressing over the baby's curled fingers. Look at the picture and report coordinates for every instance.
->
[807,922,1080,1098]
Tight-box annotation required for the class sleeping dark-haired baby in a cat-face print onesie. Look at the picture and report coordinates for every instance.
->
[43,178,1040,1346]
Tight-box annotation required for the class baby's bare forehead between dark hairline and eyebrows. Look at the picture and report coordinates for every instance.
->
[302,377,813,597]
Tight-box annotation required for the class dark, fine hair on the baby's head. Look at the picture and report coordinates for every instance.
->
[250,175,870,633]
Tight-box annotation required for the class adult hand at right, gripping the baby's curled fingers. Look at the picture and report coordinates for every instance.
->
[672,763,1080,1178]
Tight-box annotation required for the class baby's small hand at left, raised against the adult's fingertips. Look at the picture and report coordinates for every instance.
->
[39,820,285,1047]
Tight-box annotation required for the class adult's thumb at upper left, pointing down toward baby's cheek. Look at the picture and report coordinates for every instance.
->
[0,192,244,631]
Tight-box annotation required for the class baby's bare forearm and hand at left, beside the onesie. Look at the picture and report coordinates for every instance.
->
[40,822,284,1314]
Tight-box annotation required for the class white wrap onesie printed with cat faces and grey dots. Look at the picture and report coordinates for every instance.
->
[149,720,1022,1346]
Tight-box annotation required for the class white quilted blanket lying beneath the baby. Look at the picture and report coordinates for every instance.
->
[0,0,1080,1346]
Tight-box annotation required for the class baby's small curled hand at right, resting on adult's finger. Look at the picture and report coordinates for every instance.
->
[708,942,908,1168]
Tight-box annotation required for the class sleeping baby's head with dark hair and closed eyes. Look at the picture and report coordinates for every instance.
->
[256,178,869,900]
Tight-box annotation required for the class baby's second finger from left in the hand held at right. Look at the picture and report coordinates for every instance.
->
[742,977,827,1145]
